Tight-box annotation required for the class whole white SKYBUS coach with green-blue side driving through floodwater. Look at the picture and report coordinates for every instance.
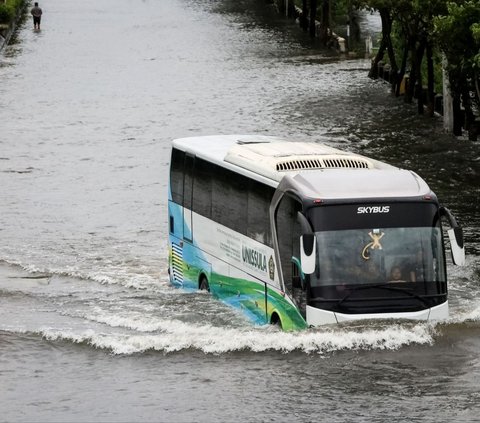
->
[168,135,465,330]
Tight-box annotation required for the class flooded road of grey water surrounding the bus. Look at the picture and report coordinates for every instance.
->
[0,0,480,422]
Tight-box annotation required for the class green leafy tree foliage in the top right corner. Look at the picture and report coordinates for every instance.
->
[295,0,480,104]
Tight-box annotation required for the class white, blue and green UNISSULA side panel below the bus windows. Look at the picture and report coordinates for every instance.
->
[169,207,306,330]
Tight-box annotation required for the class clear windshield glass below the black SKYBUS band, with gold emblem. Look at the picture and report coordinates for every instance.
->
[312,227,446,285]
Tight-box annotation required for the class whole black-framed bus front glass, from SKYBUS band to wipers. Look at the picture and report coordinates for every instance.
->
[309,203,446,313]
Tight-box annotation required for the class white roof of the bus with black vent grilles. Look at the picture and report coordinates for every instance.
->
[173,135,432,199]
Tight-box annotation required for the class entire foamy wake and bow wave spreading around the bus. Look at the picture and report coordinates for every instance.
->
[0,263,480,355]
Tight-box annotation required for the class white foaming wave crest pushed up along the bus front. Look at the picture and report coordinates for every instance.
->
[1,320,436,355]
